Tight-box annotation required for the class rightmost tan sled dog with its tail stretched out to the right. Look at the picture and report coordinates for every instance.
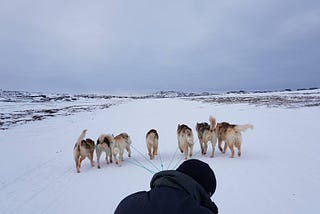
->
[215,119,253,158]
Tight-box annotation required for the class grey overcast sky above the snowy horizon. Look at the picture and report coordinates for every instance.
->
[0,0,320,92]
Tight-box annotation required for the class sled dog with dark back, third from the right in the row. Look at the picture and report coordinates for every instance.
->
[177,124,194,160]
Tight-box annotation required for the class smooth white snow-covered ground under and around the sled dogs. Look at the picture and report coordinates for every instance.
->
[0,91,320,214]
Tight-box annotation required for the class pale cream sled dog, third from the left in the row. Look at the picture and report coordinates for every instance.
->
[112,132,131,166]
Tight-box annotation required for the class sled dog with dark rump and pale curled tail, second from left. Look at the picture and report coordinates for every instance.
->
[96,134,114,169]
